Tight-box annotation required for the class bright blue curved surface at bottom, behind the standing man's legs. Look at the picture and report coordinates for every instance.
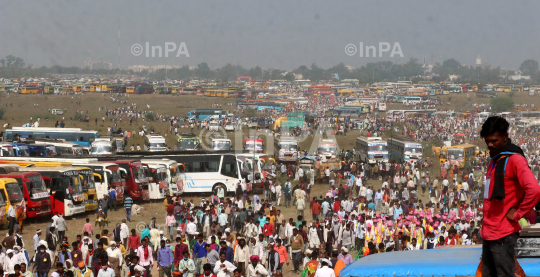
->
[339,247,540,277]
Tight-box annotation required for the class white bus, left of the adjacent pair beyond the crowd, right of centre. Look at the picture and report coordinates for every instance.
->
[355,137,388,164]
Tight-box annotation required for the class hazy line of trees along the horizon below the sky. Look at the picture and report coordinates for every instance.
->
[0,55,540,84]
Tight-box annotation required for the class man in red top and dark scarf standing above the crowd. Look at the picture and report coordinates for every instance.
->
[480,116,540,276]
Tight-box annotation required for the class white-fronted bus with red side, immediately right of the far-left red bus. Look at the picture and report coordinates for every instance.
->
[21,167,85,216]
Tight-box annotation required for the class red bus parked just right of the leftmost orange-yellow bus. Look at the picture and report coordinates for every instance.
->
[0,171,51,218]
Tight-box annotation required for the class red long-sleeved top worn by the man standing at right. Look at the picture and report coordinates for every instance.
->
[480,154,540,240]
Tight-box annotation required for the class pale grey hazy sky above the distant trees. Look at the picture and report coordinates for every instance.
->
[0,0,540,70]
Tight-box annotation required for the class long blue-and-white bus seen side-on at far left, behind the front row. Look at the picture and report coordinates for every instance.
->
[4,127,98,148]
